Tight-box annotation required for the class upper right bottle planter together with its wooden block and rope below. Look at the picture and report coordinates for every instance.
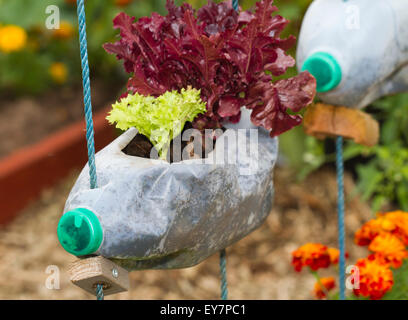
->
[297,0,408,300]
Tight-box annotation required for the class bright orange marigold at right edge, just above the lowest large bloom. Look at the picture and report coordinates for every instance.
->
[368,233,408,268]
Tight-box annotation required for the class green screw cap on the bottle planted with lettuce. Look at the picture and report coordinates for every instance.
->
[57,208,103,256]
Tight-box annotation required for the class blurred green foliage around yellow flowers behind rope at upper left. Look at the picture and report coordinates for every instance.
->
[0,0,164,95]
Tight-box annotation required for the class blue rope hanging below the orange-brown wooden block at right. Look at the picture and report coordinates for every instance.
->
[336,137,346,300]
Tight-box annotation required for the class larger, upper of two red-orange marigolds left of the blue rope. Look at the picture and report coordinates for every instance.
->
[292,243,330,272]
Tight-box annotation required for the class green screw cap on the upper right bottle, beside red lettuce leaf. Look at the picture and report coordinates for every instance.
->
[302,52,342,92]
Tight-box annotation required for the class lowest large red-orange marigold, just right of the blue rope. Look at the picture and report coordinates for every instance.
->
[351,255,394,300]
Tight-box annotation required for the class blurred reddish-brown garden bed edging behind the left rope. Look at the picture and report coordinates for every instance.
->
[0,109,115,225]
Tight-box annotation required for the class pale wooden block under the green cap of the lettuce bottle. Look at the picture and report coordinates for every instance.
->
[68,256,129,296]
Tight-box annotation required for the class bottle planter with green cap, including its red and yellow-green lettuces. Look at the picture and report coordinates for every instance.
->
[58,0,316,270]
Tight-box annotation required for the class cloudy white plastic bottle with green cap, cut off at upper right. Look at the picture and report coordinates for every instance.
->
[296,0,408,108]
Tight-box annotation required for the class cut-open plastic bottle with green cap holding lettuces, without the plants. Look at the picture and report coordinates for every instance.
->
[58,110,278,270]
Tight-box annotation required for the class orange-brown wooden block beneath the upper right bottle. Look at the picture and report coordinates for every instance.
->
[303,103,380,147]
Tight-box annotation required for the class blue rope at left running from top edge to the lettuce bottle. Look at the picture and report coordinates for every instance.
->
[77,0,97,189]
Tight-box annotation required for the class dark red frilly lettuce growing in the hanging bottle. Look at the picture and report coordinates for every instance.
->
[104,0,316,136]
